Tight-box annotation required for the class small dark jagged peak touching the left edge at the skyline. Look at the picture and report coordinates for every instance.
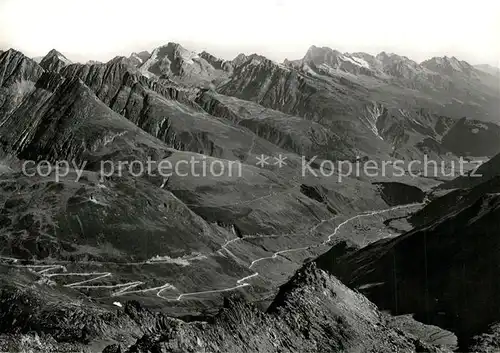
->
[0,49,44,86]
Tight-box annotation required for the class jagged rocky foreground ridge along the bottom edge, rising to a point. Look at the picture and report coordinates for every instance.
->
[0,263,452,353]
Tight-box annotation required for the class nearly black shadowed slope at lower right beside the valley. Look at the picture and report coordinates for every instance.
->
[320,166,500,350]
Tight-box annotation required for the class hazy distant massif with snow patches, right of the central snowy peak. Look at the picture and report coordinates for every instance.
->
[217,46,499,158]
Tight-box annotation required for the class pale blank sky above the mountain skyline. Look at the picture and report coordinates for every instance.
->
[0,0,500,66]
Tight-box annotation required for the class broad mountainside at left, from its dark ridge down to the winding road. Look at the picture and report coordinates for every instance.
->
[0,47,420,314]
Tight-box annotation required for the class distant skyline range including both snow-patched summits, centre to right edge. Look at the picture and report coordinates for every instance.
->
[20,43,500,159]
